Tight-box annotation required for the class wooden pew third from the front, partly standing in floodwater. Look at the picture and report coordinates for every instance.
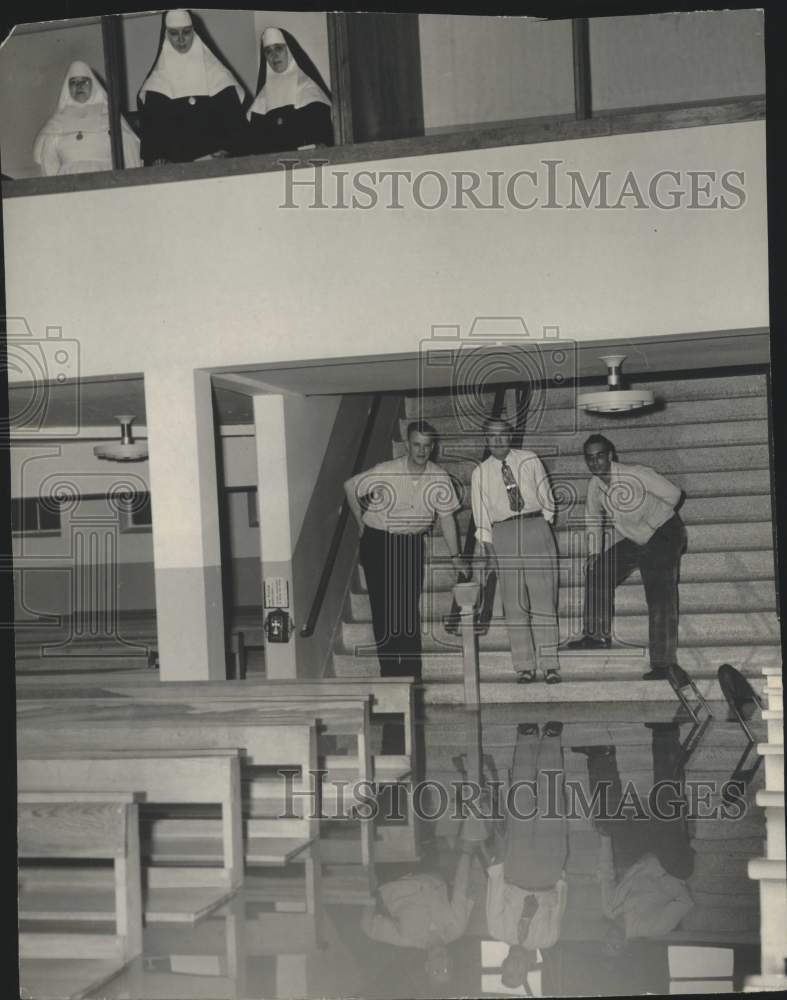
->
[17,705,317,865]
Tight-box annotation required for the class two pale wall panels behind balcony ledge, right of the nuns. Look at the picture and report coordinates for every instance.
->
[418,10,765,132]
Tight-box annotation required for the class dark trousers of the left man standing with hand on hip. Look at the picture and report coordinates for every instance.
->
[361,527,424,680]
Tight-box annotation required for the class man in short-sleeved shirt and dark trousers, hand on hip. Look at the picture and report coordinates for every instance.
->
[344,421,463,679]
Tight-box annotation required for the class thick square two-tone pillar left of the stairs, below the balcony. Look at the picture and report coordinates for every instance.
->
[145,368,226,681]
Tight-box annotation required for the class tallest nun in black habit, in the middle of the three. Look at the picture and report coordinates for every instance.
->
[137,10,246,166]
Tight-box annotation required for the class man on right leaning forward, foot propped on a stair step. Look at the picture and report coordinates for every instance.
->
[567,434,686,680]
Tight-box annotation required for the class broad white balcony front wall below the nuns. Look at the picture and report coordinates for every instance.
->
[3,122,768,381]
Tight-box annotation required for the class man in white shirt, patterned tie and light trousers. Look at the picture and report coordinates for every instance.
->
[470,417,560,684]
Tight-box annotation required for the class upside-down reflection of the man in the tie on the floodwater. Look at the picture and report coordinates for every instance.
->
[486,722,568,967]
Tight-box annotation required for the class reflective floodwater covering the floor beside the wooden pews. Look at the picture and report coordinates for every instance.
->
[21,704,765,1000]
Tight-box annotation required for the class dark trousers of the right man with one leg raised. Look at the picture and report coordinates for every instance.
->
[585,514,686,670]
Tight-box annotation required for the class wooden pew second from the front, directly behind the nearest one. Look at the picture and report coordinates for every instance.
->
[17,749,243,921]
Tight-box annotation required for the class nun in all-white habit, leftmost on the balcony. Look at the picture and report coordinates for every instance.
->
[33,61,142,177]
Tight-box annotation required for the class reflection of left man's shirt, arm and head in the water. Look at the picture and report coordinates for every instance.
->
[361,840,477,982]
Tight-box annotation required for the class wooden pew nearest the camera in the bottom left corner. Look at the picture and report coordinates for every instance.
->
[18,792,142,1000]
